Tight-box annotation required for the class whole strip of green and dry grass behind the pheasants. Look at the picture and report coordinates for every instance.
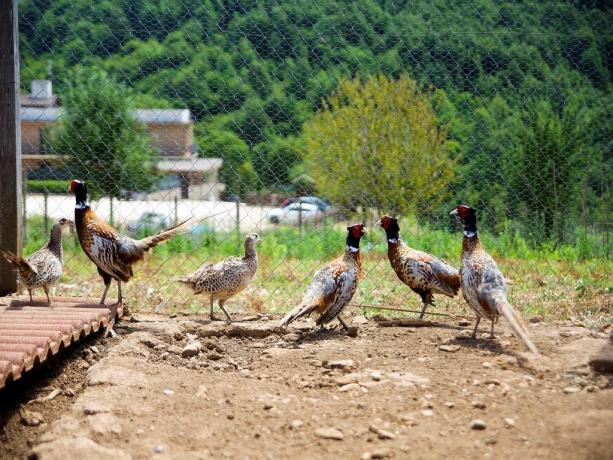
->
[20,218,613,327]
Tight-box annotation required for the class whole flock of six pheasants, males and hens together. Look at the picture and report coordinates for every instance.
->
[2,180,539,354]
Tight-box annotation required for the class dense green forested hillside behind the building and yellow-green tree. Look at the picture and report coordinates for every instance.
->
[19,0,613,244]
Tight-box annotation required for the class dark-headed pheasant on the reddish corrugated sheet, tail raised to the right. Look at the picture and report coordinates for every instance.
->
[68,180,187,304]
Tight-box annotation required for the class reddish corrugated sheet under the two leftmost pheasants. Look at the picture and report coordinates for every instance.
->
[0,297,123,389]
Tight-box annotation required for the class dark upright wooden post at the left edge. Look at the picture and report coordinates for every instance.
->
[0,0,22,295]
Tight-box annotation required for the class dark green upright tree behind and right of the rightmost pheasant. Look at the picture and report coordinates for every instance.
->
[506,96,593,243]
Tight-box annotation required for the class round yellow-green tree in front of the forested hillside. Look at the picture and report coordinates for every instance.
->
[304,75,457,213]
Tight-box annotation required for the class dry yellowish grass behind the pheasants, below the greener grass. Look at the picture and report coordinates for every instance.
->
[57,244,613,327]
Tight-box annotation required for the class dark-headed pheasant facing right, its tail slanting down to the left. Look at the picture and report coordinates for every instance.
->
[280,224,365,331]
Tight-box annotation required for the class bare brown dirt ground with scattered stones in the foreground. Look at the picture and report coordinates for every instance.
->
[0,315,613,460]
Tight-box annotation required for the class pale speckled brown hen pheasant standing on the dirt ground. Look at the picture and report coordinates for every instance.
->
[177,233,262,323]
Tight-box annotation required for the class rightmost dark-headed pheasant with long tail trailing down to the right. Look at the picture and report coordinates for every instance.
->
[451,204,539,354]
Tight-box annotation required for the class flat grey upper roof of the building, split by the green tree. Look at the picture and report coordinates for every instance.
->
[20,107,192,125]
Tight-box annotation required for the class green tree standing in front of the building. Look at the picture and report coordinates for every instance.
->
[52,71,157,198]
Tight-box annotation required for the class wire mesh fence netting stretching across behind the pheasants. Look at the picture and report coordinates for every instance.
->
[13,0,613,322]
